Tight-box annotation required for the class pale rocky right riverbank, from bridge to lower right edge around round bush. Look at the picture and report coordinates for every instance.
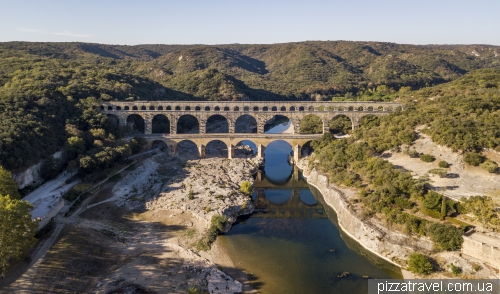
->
[297,158,498,279]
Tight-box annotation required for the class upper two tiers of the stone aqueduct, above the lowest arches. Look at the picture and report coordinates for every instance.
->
[100,101,403,134]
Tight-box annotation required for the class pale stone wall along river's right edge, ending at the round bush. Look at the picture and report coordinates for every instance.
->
[307,169,432,266]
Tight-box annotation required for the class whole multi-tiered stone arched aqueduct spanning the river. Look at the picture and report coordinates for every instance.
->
[100,101,403,161]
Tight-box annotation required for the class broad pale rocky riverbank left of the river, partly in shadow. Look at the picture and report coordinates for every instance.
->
[2,154,259,293]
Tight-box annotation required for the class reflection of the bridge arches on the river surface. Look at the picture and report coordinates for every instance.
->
[252,167,328,218]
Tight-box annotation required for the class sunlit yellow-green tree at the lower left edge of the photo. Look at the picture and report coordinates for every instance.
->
[0,195,38,278]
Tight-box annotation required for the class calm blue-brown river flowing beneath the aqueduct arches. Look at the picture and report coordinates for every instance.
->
[220,121,401,294]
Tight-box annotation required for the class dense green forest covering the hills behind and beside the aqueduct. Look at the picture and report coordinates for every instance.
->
[0,41,500,172]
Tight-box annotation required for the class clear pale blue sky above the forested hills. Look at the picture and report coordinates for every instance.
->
[0,0,500,45]
